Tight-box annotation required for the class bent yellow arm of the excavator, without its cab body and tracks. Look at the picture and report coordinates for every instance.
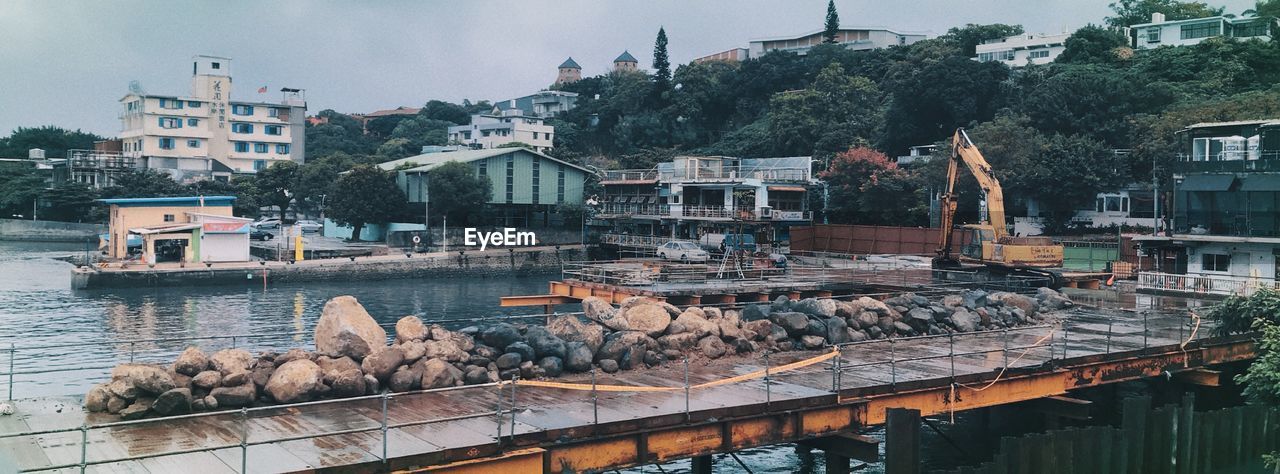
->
[938,128,1006,260]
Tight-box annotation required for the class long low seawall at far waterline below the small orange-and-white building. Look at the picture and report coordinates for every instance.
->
[72,246,586,290]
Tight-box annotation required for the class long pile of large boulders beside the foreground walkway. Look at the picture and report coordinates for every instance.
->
[84,288,1073,419]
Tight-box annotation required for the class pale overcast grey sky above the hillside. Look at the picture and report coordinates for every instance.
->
[0,0,1253,136]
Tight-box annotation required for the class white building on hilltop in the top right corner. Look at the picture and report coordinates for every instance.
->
[1132,13,1276,49]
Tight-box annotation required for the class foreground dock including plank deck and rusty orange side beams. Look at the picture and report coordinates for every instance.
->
[0,304,1253,473]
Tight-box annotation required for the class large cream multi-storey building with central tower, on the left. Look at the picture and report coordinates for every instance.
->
[120,55,307,181]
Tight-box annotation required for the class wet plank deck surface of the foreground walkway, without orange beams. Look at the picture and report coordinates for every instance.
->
[0,304,1210,473]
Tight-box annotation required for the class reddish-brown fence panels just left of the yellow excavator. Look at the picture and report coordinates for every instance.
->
[791,224,969,255]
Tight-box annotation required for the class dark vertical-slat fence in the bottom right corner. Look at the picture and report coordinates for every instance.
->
[934,395,1280,474]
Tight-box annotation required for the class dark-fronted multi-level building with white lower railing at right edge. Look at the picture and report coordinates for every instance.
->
[1135,119,1280,292]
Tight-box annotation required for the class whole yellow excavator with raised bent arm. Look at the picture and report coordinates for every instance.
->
[933,128,1062,288]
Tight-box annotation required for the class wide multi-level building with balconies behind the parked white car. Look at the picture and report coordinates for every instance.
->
[594,156,818,242]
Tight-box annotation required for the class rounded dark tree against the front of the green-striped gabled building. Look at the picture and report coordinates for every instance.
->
[428,161,493,225]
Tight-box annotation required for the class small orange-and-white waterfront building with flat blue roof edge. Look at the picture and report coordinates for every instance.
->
[99,196,252,265]
